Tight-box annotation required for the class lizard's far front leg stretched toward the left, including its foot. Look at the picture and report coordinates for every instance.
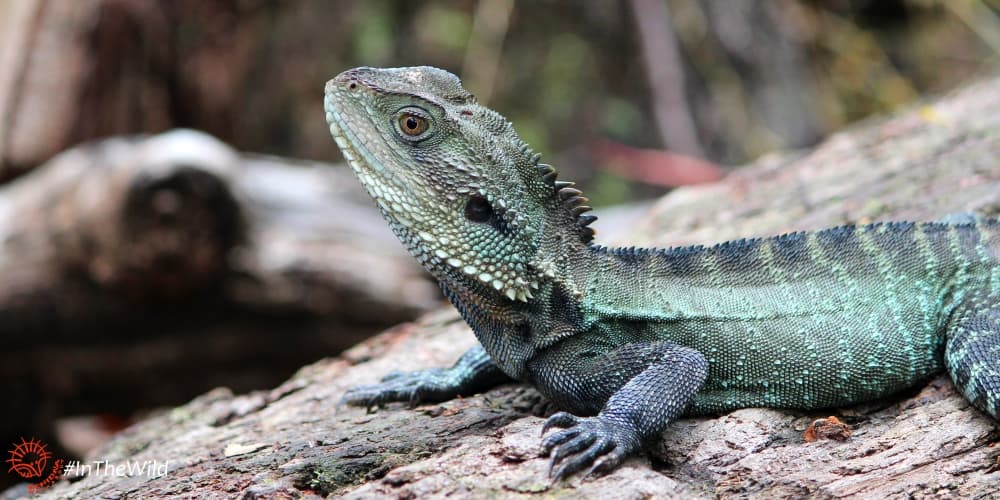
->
[341,344,511,408]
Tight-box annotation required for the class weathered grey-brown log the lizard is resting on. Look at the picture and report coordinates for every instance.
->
[17,78,1000,499]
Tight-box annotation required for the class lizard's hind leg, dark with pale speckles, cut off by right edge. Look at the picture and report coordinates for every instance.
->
[945,304,1000,421]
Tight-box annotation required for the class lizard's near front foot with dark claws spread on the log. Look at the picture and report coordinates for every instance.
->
[542,412,639,481]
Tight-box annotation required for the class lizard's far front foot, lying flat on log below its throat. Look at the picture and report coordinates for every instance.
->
[339,368,456,410]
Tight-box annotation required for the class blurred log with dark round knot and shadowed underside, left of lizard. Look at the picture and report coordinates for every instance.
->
[0,131,441,450]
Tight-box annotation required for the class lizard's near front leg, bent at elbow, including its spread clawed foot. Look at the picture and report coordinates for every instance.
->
[540,342,708,480]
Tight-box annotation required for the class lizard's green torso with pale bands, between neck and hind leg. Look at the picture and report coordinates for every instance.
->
[583,220,1000,413]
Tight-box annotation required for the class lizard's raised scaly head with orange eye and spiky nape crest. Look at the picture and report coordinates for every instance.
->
[324,66,595,301]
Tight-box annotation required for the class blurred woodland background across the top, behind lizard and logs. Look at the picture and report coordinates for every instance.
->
[0,0,1000,205]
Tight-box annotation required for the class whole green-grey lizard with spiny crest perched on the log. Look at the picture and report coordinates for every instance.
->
[324,66,1000,480]
